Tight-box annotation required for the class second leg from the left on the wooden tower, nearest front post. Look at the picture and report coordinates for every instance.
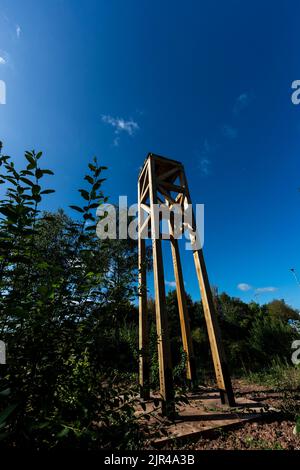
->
[148,157,175,416]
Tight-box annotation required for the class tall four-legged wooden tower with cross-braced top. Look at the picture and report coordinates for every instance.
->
[138,153,235,415]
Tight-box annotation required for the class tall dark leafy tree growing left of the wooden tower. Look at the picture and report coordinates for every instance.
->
[0,145,142,448]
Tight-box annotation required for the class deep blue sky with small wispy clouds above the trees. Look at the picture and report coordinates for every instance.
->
[0,0,300,308]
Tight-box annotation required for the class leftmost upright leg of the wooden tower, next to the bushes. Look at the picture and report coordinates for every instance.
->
[138,178,150,400]
